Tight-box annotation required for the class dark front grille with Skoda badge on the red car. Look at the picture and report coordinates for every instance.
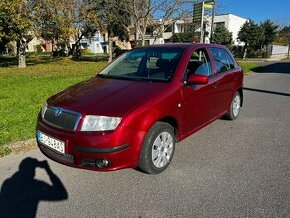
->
[43,107,81,131]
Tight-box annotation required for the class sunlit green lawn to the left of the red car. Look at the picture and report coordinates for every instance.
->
[0,57,106,147]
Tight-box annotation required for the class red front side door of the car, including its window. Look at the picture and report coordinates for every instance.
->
[182,48,216,132]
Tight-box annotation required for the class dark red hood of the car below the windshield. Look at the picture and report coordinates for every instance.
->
[48,77,168,117]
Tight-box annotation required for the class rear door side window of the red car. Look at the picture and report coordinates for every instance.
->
[210,48,235,73]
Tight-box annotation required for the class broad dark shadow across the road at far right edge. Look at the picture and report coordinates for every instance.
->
[252,62,290,74]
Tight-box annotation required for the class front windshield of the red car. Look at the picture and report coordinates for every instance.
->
[98,47,184,82]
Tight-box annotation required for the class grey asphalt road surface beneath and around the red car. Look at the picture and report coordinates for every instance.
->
[0,63,290,217]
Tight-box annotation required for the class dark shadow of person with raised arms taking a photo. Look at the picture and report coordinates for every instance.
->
[0,158,68,218]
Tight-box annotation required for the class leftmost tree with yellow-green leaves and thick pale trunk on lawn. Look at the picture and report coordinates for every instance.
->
[0,0,35,68]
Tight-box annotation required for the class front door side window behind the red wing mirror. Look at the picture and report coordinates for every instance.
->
[187,49,212,76]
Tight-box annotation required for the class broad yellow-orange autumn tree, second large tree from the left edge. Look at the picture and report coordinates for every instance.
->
[37,0,100,57]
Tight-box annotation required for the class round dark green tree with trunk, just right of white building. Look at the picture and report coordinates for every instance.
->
[238,20,264,58]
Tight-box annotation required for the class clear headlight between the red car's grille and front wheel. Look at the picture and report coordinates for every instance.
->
[81,115,122,131]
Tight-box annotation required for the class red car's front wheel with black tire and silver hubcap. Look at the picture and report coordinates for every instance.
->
[138,122,175,174]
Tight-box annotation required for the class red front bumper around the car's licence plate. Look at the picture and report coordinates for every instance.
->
[36,117,146,171]
